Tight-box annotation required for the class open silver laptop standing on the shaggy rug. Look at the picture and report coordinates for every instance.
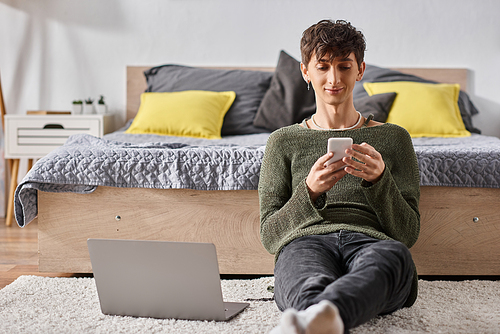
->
[87,239,249,321]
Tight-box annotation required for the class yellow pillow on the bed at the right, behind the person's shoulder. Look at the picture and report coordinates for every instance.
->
[363,81,470,137]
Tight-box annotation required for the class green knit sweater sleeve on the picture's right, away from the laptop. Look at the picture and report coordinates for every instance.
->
[361,131,420,248]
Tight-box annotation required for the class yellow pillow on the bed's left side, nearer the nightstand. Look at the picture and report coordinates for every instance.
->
[125,90,236,139]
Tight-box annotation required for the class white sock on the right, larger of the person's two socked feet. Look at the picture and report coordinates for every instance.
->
[298,300,344,334]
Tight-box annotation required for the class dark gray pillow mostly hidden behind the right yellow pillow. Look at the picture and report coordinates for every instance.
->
[353,65,481,133]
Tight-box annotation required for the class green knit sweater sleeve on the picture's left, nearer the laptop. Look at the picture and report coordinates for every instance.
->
[259,134,323,254]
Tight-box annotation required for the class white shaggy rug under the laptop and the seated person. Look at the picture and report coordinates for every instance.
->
[0,276,500,334]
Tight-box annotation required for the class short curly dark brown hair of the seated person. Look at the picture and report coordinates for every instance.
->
[300,20,366,67]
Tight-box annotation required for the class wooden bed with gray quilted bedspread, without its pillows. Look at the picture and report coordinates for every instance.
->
[15,53,500,275]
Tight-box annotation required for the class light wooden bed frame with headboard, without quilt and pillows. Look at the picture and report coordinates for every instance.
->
[38,67,500,275]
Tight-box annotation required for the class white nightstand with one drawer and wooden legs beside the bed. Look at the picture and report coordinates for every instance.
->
[5,114,114,225]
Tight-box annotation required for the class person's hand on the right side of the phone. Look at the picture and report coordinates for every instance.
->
[342,143,385,183]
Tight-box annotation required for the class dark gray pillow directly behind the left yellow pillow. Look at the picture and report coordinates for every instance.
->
[144,65,273,136]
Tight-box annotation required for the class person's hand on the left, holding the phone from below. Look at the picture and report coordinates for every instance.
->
[306,152,347,202]
